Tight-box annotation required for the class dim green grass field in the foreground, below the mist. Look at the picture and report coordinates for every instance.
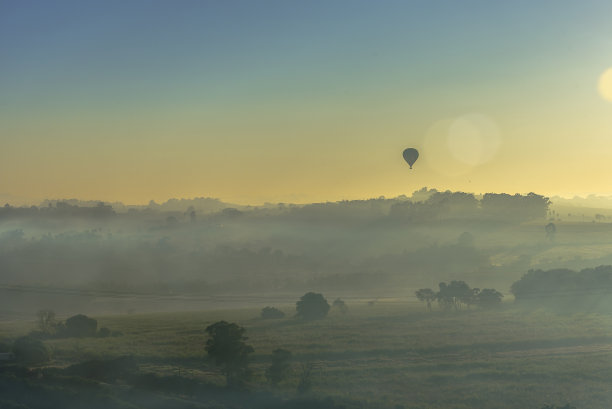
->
[0,302,612,409]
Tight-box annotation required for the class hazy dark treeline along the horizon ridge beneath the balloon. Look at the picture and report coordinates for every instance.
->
[0,188,550,222]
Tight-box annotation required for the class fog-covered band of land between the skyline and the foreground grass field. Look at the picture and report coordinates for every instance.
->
[0,188,612,312]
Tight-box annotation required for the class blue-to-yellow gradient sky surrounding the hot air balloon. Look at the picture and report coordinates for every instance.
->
[0,0,612,204]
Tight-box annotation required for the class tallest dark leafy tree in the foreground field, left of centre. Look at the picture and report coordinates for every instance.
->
[205,321,254,386]
